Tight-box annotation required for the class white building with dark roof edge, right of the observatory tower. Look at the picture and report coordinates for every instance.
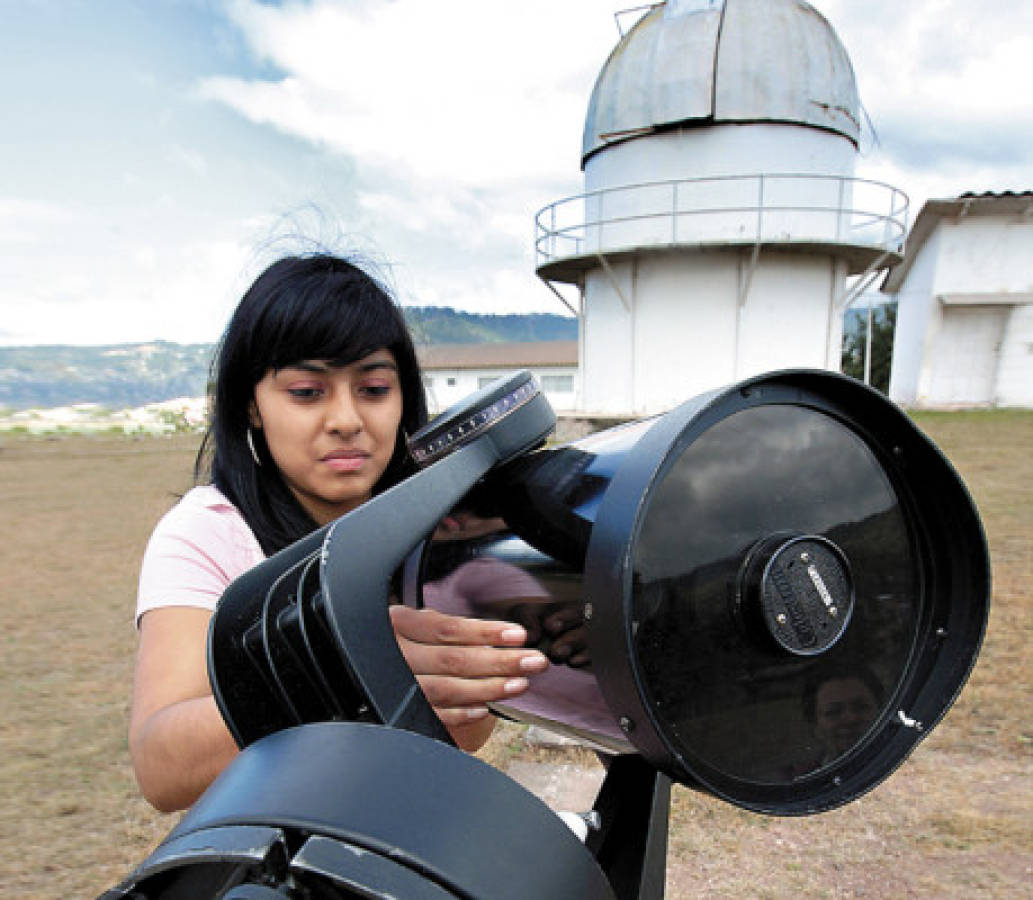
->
[882,197,1033,408]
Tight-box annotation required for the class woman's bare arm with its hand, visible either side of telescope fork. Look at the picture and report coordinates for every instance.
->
[129,607,549,812]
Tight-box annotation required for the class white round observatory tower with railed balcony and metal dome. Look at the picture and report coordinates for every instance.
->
[535,0,907,415]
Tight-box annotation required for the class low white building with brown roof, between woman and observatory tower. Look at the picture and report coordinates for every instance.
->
[416,341,577,414]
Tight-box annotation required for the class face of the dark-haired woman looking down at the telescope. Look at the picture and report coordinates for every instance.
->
[251,349,402,525]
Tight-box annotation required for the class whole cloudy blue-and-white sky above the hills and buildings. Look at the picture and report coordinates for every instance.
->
[0,0,1033,346]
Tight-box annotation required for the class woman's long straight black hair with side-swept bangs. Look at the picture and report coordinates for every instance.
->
[194,254,427,554]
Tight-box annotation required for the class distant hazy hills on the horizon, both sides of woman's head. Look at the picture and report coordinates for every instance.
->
[0,307,577,409]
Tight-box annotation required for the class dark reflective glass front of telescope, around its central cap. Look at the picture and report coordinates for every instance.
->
[632,405,919,784]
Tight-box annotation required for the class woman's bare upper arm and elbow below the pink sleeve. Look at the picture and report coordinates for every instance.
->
[129,607,238,812]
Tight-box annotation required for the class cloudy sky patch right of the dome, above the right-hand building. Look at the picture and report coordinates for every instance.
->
[818,0,1033,206]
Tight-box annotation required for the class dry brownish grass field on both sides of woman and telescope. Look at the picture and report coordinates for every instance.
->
[0,411,1033,898]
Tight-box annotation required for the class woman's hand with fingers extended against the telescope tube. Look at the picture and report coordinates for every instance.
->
[389,606,549,750]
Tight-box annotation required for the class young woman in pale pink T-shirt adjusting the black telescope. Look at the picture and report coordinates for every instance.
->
[129,255,549,811]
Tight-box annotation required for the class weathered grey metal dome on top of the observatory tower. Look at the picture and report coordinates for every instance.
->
[582,0,860,165]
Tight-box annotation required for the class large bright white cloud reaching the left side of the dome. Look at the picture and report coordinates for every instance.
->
[199,0,617,186]
